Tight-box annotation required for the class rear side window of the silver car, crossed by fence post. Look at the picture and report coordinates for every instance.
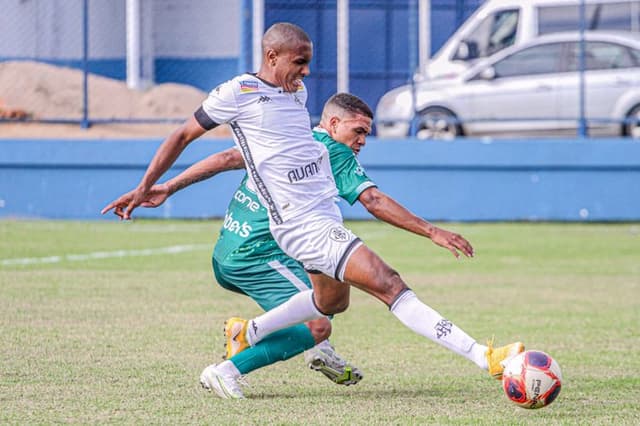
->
[567,41,636,71]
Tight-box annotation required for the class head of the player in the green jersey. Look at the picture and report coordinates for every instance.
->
[320,93,373,154]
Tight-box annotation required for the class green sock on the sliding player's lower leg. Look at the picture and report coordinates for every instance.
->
[230,324,316,374]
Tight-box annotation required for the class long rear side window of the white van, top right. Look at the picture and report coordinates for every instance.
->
[538,1,640,34]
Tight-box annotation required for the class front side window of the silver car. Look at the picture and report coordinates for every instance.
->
[493,43,562,78]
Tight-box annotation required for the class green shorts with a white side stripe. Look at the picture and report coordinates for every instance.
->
[211,252,311,311]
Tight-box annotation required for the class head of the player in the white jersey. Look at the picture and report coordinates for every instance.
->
[259,22,313,92]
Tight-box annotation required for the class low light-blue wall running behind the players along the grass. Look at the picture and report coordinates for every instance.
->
[0,138,640,221]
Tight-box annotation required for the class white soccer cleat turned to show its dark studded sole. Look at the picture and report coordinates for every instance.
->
[304,344,363,386]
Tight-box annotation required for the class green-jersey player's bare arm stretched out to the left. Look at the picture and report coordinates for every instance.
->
[102,148,244,219]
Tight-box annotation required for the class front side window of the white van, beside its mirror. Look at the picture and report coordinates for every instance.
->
[464,9,519,59]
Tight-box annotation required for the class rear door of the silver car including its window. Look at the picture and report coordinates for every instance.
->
[559,41,639,134]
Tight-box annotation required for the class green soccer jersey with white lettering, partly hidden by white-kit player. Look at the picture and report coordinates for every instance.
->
[213,127,376,263]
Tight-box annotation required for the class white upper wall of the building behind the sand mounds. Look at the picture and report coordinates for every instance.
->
[0,0,240,60]
